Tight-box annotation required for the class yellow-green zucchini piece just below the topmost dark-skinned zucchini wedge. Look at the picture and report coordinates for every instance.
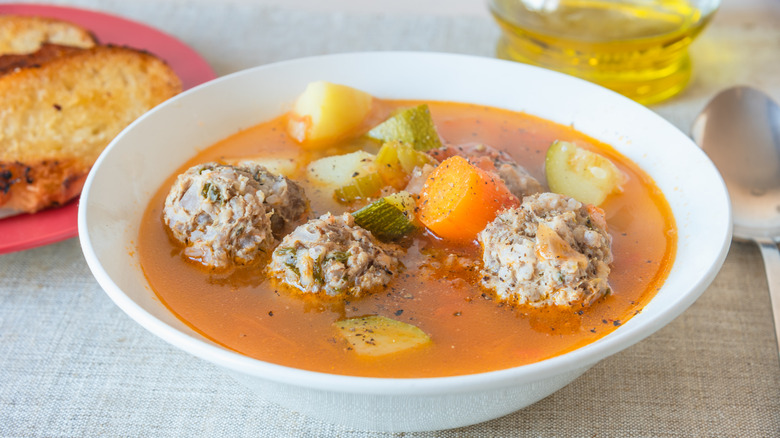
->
[376,141,438,190]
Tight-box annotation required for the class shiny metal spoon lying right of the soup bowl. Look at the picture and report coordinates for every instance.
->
[692,87,780,356]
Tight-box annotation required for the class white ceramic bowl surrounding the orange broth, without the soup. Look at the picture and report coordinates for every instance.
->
[79,52,731,431]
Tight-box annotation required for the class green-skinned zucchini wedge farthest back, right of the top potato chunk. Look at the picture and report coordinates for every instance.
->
[367,104,441,152]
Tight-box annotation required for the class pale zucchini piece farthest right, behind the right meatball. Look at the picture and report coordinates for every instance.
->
[544,141,624,205]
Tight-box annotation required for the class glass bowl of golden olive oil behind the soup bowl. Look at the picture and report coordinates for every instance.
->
[488,0,720,104]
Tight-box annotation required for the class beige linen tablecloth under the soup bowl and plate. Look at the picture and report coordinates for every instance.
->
[0,0,780,437]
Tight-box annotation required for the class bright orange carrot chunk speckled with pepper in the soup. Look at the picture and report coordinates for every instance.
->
[418,156,519,243]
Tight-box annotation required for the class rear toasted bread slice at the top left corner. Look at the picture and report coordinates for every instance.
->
[0,15,97,55]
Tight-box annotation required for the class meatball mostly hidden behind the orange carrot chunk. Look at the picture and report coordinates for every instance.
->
[429,143,544,200]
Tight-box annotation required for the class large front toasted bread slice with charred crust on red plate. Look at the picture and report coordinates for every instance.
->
[0,46,181,215]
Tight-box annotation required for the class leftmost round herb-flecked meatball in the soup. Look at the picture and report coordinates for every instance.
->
[163,163,275,268]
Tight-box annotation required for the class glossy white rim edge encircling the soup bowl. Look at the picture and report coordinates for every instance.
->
[78,51,731,395]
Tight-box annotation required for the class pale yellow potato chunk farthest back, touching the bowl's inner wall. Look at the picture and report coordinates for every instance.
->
[287,81,373,148]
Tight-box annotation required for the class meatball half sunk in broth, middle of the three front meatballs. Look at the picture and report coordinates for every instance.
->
[268,213,400,298]
